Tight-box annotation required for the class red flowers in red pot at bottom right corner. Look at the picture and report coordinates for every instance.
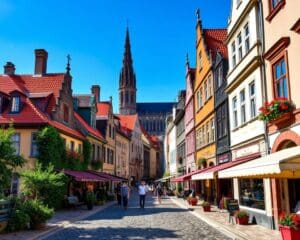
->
[279,213,300,240]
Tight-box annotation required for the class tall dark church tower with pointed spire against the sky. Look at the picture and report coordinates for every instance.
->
[119,28,136,115]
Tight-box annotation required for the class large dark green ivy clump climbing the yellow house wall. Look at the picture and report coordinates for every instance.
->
[37,126,65,169]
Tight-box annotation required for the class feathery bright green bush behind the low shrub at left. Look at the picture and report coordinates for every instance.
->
[21,164,67,208]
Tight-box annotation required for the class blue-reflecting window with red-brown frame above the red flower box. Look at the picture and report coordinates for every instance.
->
[273,58,289,98]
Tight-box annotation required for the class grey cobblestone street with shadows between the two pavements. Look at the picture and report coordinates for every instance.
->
[43,191,231,240]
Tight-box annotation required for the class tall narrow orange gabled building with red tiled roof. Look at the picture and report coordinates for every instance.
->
[194,10,227,201]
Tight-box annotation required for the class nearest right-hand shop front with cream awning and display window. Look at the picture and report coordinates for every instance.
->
[218,147,300,229]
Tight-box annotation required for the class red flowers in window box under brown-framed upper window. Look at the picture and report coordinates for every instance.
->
[258,98,295,123]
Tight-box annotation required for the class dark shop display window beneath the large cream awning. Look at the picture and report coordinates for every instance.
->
[239,178,265,210]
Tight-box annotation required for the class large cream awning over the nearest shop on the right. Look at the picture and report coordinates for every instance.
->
[218,146,300,178]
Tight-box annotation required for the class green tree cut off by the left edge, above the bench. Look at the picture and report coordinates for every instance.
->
[0,126,25,195]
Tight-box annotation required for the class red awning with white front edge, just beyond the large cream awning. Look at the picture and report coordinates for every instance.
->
[192,158,250,180]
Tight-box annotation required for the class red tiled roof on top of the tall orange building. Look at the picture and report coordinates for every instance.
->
[203,29,228,59]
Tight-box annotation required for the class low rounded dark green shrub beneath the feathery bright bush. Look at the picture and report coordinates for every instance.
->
[23,200,54,229]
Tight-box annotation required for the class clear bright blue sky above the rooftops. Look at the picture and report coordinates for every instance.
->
[0,0,231,111]
